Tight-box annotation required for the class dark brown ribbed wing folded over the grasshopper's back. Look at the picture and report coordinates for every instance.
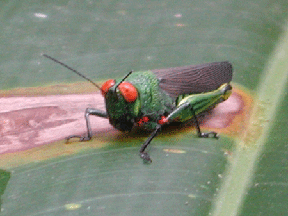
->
[152,61,232,98]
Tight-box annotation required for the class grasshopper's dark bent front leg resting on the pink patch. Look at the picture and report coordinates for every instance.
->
[66,108,108,143]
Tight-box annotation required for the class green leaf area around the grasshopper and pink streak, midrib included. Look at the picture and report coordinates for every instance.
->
[0,0,288,216]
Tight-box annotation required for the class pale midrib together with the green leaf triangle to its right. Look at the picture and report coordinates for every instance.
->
[210,25,288,215]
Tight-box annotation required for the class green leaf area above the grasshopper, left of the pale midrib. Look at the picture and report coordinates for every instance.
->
[0,0,287,89]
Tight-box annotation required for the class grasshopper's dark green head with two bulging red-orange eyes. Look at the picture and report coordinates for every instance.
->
[101,79,138,131]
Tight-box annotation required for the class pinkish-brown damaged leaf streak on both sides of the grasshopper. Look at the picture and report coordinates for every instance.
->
[0,82,253,157]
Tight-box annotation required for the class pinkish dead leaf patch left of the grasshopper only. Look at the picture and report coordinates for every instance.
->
[0,93,113,153]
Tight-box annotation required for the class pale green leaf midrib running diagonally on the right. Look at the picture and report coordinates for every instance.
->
[211,22,288,216]
